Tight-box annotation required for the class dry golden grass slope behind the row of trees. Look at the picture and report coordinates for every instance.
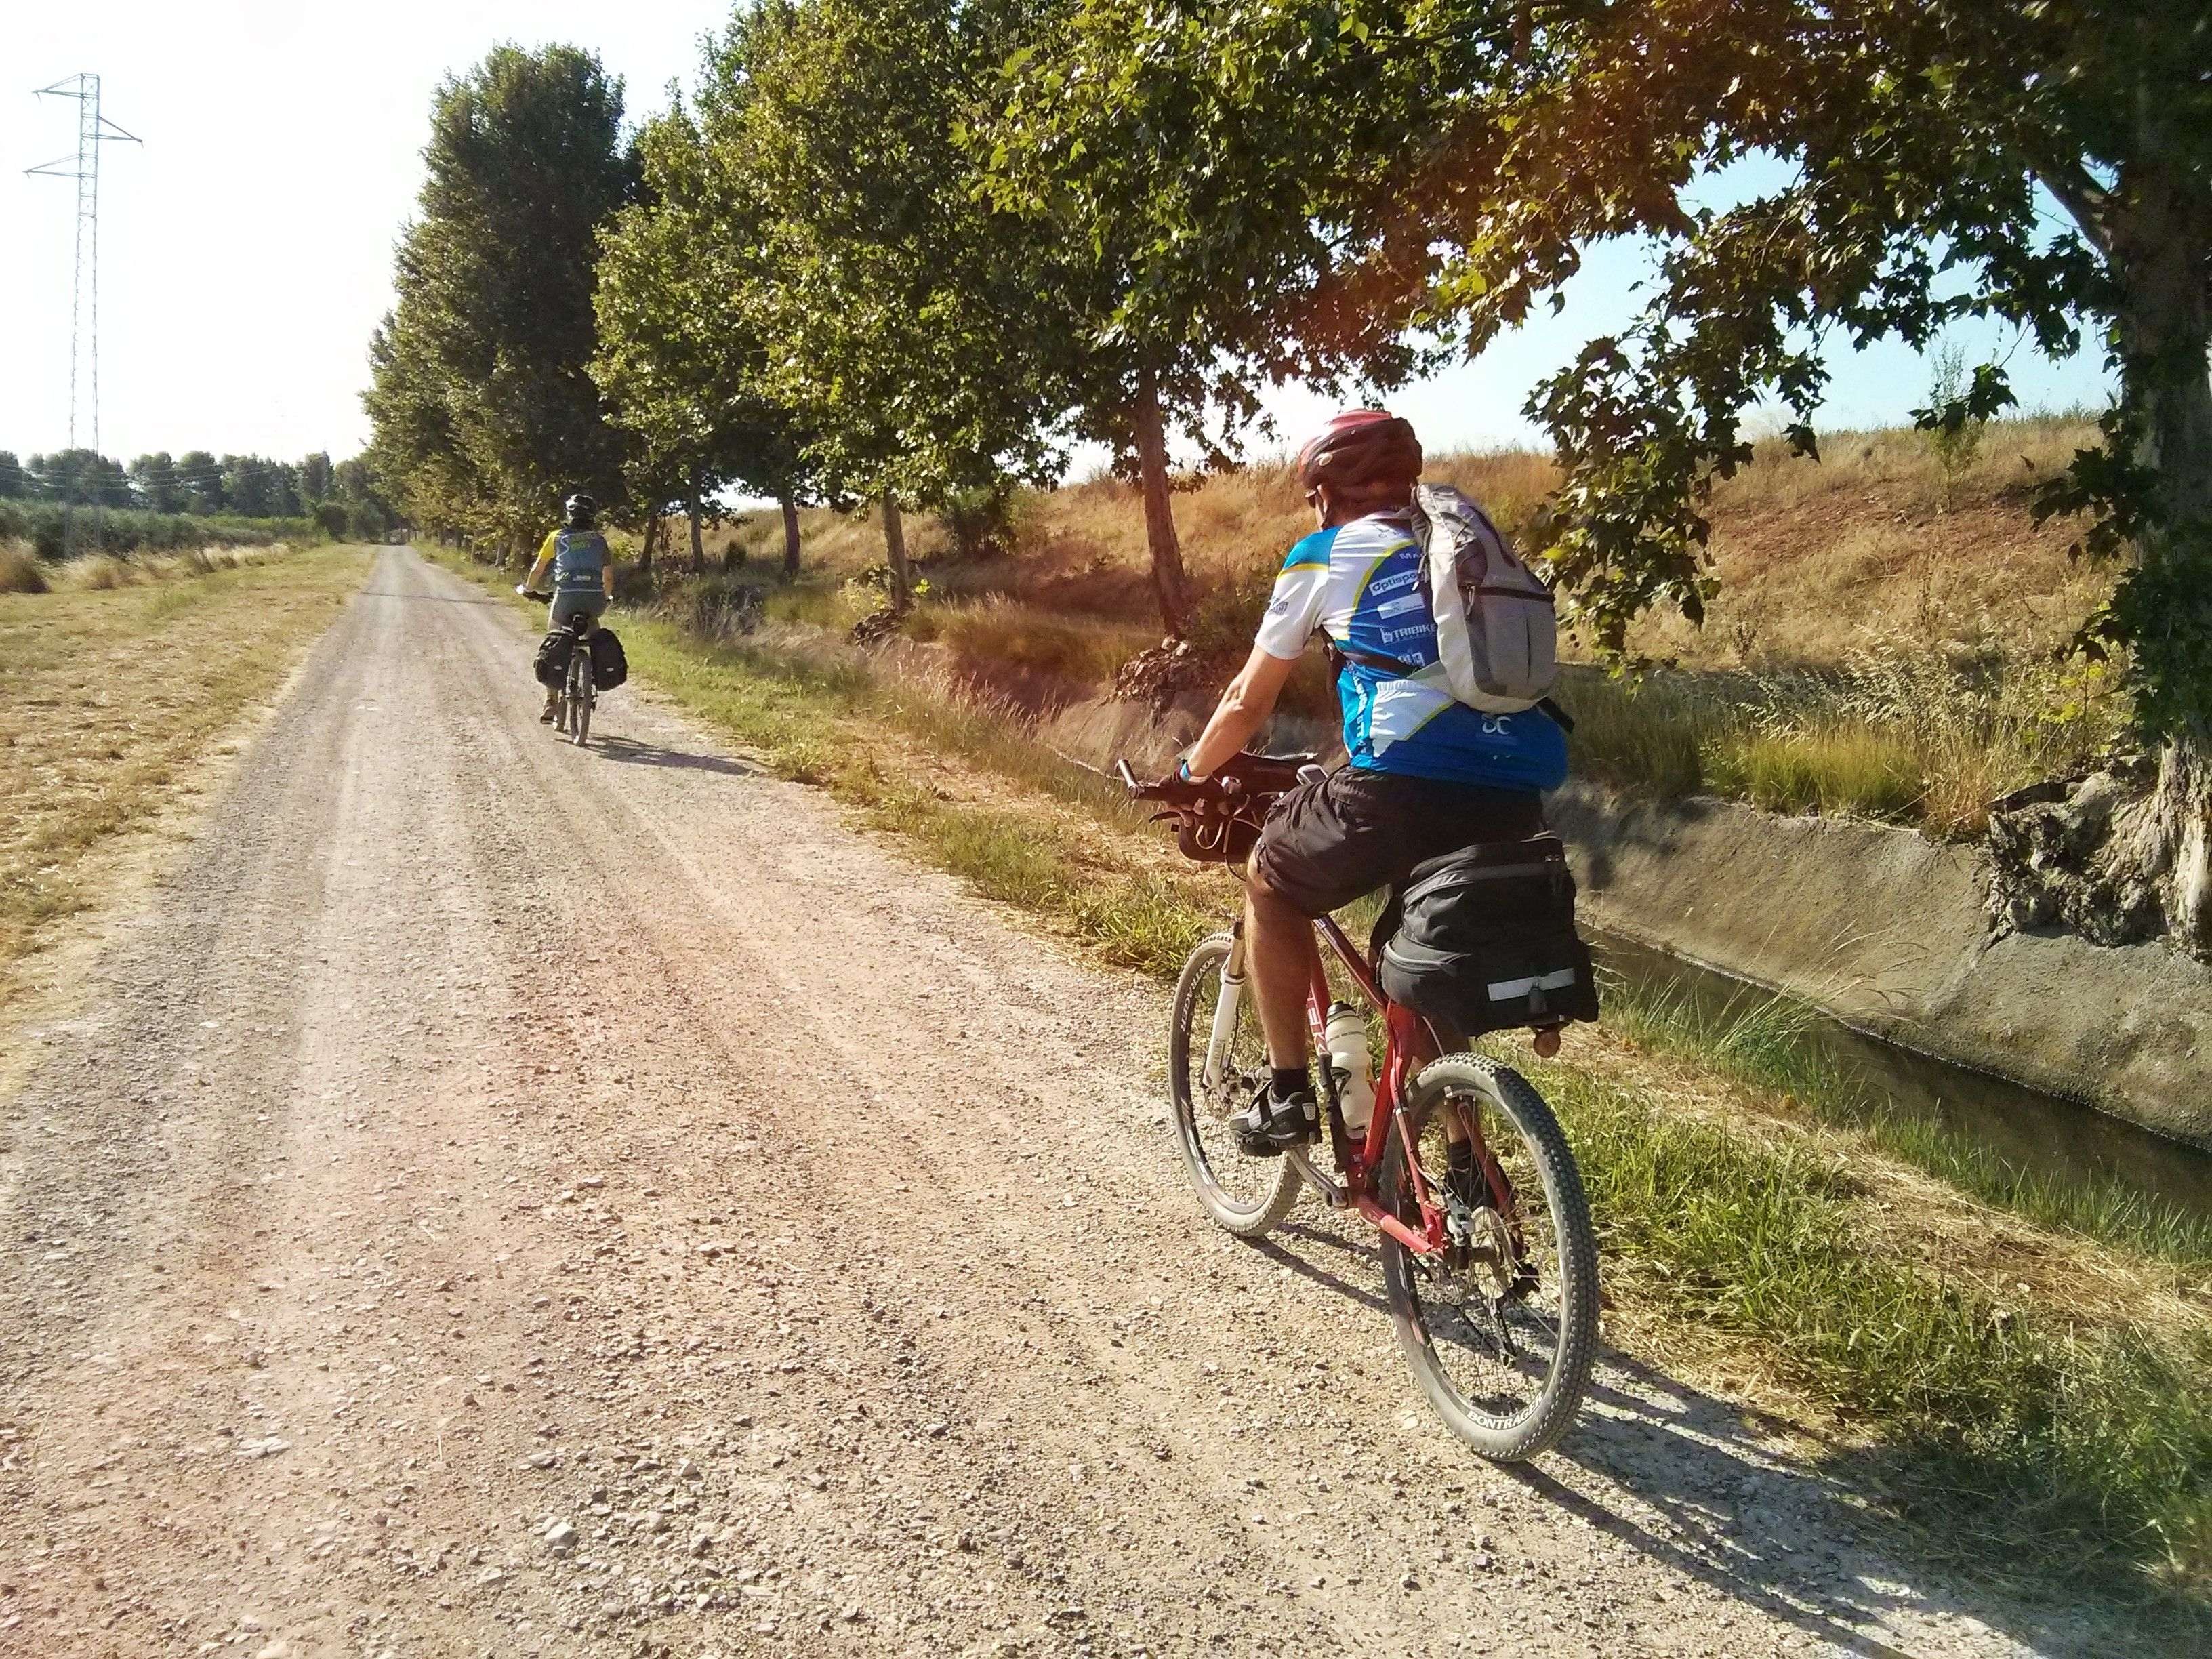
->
[668,416,2108,668]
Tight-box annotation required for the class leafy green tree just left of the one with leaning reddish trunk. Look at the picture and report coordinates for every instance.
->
[701,0,1059,611]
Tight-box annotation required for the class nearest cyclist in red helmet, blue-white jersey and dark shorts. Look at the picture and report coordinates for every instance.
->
[1181,409,1566,1155]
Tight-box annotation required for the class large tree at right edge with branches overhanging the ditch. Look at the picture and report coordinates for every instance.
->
[1150,0,2212,956]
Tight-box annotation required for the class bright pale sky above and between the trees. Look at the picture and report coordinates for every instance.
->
[0,0,2104,471]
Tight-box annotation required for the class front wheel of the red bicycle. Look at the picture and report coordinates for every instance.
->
[1168,933,1300,1239]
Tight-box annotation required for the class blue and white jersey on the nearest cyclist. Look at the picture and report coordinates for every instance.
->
[1258,511,1566,790]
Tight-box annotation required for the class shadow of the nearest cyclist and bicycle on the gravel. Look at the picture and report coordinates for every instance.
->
[1258,1223,2176,1659]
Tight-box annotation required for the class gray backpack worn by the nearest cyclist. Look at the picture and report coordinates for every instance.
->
[1414,485,1559,714]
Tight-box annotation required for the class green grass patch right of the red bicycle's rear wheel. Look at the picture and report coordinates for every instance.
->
[1533,1064,2212,1593]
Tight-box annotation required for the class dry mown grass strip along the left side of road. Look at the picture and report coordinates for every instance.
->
[0,548,369,989]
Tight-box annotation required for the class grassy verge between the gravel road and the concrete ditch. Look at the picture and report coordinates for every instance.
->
[436,553,2212,1628]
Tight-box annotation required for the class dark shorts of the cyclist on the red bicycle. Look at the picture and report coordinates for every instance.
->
[1252,765,1544,916]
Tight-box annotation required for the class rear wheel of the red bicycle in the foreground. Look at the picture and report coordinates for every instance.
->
[1382,1053,1597,1462]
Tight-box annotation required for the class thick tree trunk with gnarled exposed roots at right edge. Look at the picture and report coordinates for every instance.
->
[1988,164,2212,960]
